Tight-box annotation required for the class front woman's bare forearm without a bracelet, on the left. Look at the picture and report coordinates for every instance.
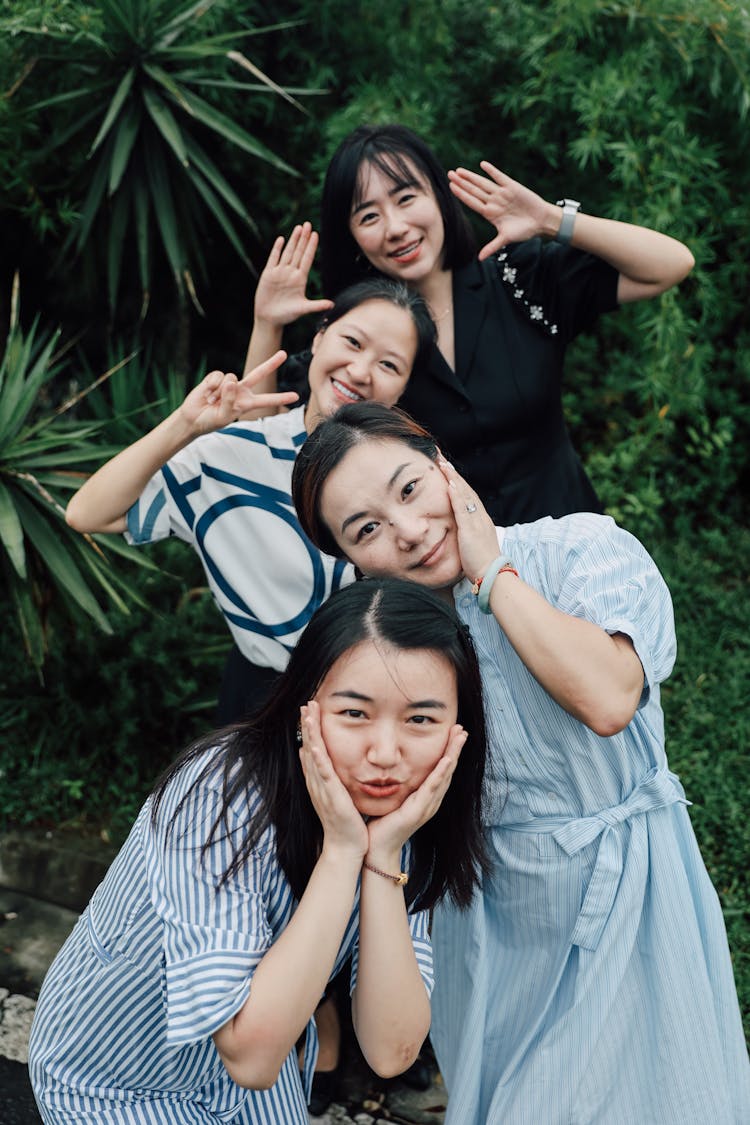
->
[214,852,361,1089]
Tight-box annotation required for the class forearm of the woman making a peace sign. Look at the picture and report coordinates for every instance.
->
[65,410,197,531]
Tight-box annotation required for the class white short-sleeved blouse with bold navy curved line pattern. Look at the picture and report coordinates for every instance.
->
[125,406,354,672]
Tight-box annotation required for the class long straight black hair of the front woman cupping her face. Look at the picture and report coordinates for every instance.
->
[152,578,489,909]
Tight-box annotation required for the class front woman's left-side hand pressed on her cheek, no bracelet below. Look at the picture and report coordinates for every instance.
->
[299,700,368,857]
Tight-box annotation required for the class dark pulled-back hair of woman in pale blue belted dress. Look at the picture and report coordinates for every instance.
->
[291,402,437,557]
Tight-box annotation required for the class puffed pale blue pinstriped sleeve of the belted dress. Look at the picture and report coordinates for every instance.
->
[557,516,677,707]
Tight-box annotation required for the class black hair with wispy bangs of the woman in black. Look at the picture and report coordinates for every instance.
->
[320,125,476,294]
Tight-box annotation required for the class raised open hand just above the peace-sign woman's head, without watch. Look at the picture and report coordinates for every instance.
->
[255,223,333,329]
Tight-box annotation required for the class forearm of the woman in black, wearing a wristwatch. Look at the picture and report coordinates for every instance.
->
[541,204,695,304]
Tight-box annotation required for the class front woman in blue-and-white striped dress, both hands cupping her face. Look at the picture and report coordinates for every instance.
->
[29,581,487,1125]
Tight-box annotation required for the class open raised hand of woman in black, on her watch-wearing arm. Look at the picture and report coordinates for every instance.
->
[448,160,552,260]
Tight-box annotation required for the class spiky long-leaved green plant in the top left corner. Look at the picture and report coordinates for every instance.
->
[0,0,301,307]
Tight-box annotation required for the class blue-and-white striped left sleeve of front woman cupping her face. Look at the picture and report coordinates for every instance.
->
[148,765,275,1044]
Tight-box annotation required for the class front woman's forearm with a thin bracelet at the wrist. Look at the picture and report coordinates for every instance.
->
[352,854,430,1078]
